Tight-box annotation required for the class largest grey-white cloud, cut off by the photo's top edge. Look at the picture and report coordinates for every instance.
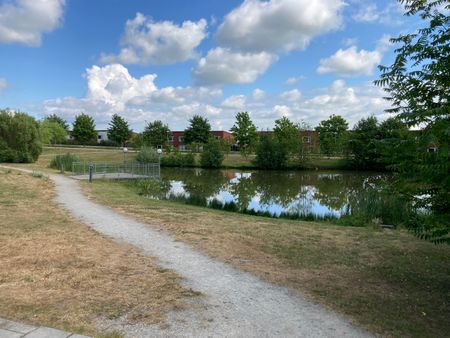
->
[217,0,344,53]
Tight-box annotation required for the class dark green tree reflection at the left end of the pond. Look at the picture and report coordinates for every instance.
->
[161,168,228,197]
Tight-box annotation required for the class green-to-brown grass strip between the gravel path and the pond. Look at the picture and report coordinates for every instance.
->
[84,181,450,337]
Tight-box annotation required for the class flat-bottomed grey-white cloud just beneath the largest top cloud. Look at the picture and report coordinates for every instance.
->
[193,47,277,85]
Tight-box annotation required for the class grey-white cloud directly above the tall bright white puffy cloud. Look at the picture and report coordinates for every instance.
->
[100,13,207,65]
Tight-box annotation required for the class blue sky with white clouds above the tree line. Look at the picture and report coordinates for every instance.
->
[0,0,421,131]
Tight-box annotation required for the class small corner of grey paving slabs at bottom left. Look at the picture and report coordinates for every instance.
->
[0,318,89,338]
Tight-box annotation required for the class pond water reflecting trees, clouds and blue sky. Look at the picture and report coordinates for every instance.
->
[161,168,389,217]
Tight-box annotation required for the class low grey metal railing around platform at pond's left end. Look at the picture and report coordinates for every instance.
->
[72,162,161,179]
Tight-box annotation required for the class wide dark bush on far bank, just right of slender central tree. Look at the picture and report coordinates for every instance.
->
[254,135,288,169]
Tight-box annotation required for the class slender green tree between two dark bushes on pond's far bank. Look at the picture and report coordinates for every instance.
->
[231,112,258,156]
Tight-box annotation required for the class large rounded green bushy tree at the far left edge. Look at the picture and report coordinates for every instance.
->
[0,109,42,163]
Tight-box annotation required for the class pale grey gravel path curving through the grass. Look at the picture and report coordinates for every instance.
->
[50,175,370,337]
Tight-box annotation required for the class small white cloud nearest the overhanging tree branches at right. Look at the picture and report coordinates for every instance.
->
[317,46,382,76]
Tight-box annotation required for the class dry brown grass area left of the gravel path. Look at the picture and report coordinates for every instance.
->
[0,173,191,334]
